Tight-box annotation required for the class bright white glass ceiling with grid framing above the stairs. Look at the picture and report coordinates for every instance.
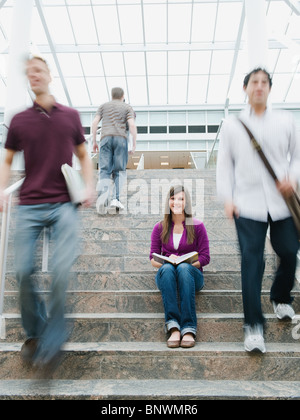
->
[0,0,300,108]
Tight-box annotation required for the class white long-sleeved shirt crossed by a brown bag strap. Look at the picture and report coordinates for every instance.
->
[217,106,300,222]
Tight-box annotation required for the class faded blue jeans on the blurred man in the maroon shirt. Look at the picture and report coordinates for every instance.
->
[15,203,78,362]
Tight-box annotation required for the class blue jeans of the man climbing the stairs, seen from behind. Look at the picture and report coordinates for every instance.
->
[98,136,128,203]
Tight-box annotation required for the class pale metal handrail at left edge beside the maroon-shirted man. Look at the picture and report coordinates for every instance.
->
[0,178,25,339]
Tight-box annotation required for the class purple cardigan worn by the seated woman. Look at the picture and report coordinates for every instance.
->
[150,219,210,271]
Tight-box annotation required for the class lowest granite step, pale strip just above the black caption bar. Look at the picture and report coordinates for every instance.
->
[0,379,300,398]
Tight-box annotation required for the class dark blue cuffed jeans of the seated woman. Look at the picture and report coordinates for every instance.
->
[156,263,204,336]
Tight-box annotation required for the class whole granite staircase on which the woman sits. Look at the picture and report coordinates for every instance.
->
[0,170,300,400]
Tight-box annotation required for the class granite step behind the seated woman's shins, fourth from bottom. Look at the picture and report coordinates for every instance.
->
[4,289,300,314]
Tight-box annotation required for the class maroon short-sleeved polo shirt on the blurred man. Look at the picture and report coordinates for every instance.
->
[5,103,85,205]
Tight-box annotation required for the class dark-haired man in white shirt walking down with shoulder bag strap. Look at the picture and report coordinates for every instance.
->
[217,68,300,353]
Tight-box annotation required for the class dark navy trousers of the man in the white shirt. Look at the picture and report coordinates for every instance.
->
[235,217,299,326]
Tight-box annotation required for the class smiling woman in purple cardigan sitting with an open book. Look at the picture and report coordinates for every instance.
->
[150,185,210,348]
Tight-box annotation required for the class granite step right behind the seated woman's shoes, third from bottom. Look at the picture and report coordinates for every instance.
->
[3,312,299,343]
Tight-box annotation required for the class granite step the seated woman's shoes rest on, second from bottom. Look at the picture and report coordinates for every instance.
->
[0,342,300,381]
